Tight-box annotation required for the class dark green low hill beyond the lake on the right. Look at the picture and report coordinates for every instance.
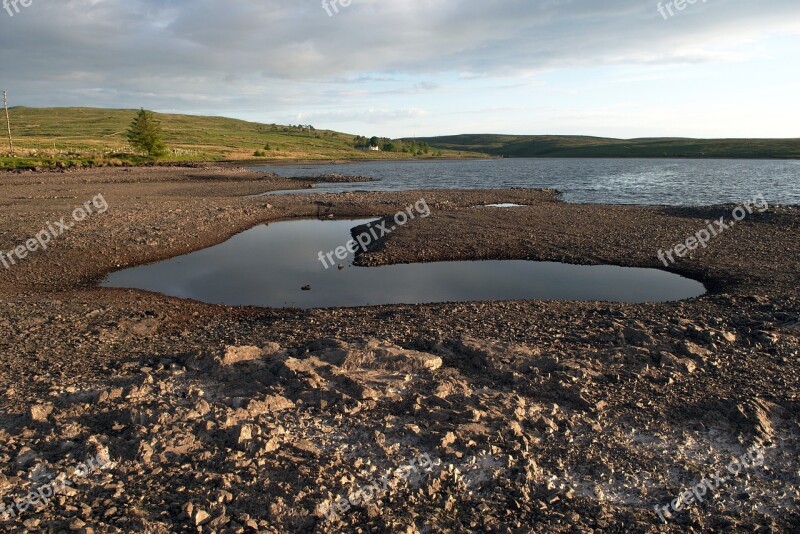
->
[423,134,800,158]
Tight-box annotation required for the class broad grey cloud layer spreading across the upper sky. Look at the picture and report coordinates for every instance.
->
[0,0,800,136]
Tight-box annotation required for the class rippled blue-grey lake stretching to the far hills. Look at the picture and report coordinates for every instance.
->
[256,159,800,205]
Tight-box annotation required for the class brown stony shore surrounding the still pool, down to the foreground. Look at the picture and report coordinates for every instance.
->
[0,166,800,533]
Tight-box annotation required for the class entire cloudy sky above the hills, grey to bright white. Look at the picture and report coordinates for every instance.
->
[0,0,800,138]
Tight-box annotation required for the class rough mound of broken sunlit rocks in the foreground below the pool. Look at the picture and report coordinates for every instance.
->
[0,338,799,532]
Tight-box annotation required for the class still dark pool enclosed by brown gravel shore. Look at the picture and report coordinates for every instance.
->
[102,219,705,308]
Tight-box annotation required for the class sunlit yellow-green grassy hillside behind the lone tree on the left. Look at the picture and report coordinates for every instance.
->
[0,107,476,169]
